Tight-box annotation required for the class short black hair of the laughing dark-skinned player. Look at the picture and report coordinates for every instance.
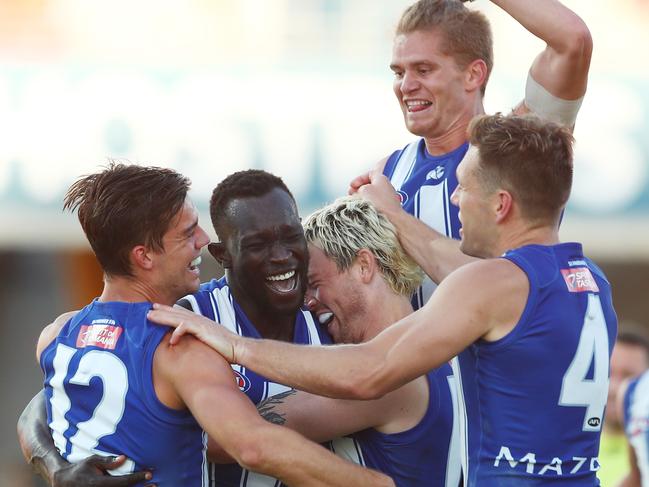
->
[210,169,295,237]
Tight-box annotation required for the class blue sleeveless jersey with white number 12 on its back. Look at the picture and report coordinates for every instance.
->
[40,300,207,486]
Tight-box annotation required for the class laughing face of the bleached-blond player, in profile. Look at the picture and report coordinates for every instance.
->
[307,244,364,343]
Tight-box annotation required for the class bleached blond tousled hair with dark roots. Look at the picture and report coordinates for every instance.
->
[303,196,424,297]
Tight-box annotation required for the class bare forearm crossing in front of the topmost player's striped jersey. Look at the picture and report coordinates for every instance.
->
[386,205,475,284]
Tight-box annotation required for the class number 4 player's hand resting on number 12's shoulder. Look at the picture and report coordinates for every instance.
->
[148,303,238,363]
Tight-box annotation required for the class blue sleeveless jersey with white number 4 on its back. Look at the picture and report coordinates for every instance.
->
[458,243,617,487]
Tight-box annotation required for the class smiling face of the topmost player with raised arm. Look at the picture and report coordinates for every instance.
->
[390,30,473,138]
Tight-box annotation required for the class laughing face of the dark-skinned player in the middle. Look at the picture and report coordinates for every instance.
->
[225,188,308,314]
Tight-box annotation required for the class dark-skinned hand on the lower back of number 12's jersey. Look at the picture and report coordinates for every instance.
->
[52,455,154,487]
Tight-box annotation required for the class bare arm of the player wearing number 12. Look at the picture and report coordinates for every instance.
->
[161,336,394,486]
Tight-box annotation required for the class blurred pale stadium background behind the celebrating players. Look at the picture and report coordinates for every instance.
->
[0,0,649,487]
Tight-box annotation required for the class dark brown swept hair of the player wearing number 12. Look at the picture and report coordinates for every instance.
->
[63,162,191,276]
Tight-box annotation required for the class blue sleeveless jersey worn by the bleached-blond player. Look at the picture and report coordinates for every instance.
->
[332,364,461,487]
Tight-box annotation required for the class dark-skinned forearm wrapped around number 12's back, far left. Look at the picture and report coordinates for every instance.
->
[17,391,68,484]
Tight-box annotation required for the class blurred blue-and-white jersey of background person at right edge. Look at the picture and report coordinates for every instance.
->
[624,372,649,487]
